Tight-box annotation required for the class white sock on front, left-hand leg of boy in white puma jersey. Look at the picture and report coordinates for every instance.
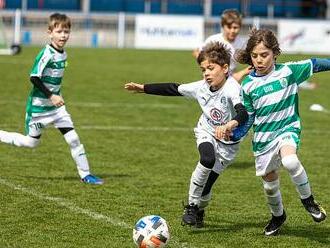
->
[189,162,211,206]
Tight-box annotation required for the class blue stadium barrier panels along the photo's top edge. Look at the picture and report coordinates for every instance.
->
[5,0,318,18]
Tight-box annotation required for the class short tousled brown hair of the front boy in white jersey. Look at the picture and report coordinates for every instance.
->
[197,42,231,66]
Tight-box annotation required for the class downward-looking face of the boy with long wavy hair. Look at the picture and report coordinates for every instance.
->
[251,42,275,75]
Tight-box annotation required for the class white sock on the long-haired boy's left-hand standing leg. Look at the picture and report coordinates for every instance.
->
[263,179,283,216]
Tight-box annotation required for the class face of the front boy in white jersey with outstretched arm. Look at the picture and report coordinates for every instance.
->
[200,60,229,90]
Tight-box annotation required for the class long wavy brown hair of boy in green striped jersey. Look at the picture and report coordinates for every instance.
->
[235,28,281,66]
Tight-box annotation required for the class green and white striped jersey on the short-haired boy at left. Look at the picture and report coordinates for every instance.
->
[26,45,67,117]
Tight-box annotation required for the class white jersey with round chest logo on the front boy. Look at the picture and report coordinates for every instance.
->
[178,77,241,144]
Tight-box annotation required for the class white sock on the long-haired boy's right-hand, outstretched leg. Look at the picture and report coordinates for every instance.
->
[282,154,312,199]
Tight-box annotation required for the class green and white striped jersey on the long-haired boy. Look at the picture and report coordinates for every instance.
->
[242,60,313,156]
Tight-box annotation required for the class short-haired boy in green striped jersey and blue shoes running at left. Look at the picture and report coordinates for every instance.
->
[0,13,103,184]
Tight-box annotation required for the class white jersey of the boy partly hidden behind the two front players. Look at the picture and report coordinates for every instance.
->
[200,33,245,74]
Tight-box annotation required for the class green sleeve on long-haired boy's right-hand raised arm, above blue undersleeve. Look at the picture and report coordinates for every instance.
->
[287,59,313,84]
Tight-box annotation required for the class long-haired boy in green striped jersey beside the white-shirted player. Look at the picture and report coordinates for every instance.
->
[217,29,330,236]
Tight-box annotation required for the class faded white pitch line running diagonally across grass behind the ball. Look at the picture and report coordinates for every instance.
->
[0,177,195,248]
